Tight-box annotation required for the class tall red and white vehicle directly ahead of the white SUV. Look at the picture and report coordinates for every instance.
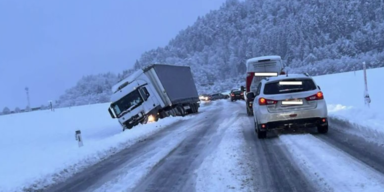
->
[241,55,285,116]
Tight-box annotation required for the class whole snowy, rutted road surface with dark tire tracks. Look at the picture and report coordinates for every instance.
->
[42,100,384,192]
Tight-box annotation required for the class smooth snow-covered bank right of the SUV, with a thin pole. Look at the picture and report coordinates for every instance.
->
[314,68,384,133]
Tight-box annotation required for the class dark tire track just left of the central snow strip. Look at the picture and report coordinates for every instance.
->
[133,101,236,191]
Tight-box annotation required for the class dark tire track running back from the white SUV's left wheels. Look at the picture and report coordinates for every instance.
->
[243,104,316,192]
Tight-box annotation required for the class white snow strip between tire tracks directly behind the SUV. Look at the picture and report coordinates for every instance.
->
[279,134,384,192]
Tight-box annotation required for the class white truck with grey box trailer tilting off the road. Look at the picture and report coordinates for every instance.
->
[108,64,200,131]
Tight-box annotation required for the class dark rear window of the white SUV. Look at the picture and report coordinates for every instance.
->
[264,79,316,95]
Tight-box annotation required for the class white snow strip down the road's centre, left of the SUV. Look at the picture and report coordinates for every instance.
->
[195,108,252,192]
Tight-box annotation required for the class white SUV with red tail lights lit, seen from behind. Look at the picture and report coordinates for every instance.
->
[251,74,328,138]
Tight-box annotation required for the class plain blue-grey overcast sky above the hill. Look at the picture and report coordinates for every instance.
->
[0,0,225,111]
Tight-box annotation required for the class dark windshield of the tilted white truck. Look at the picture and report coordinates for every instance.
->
[111,90,143,117]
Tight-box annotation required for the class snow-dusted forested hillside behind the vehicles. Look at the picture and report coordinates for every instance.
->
[56,0,384,106]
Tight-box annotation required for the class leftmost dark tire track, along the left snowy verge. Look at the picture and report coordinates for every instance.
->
[46,103,224,192]
